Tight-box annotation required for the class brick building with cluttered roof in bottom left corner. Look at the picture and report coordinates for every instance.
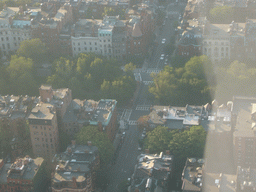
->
[0,156,44,192]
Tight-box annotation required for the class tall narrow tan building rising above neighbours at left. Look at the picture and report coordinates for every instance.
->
[28,102,59,158]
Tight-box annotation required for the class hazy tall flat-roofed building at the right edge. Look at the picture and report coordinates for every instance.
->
[232,97,256,168]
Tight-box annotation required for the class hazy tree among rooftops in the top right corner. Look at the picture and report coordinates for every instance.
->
[209,6,234,24]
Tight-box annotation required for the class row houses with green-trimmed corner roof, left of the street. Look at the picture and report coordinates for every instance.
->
[62,99,117,141]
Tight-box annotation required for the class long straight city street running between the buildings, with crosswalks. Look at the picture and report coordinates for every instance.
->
[106,3,185,192]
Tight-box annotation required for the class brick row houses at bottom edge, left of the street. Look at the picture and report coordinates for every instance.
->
[52,141,100,192]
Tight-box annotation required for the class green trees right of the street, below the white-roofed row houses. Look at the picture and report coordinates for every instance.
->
[145,126,206,160]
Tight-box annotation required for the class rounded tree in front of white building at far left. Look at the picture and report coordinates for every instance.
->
[17,39,47,65]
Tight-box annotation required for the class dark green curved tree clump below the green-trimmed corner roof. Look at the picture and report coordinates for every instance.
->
[76,126,114,167]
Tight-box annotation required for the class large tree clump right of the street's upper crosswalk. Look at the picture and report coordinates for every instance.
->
[149,56,215,106]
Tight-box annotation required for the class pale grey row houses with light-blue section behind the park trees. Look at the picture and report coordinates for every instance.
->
[71,16,126,59]
